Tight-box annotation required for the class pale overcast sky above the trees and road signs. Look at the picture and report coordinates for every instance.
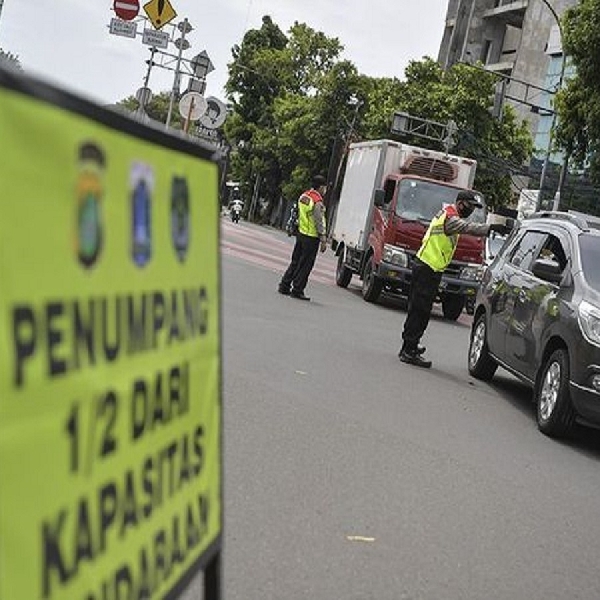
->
[0,0,447,104]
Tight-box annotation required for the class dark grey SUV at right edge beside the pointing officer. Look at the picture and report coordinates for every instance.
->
[468,212,600,437]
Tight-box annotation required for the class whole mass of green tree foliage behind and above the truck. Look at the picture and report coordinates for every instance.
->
[225,16,533,219]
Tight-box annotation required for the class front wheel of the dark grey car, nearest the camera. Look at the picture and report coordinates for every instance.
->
[535,348,575,437]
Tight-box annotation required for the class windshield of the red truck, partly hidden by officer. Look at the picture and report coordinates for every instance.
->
[396,179,485,223]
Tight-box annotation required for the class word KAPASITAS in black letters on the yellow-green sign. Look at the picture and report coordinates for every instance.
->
[40,425,205,598]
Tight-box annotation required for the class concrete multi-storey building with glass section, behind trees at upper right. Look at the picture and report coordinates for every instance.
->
[438,0,577,199]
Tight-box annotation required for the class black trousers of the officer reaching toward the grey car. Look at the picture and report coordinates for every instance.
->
[402,258,442,352]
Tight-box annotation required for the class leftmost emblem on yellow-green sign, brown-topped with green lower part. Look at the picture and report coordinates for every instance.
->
[76,142,106,268]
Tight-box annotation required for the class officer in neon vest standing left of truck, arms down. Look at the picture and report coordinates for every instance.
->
[278,175,327,300]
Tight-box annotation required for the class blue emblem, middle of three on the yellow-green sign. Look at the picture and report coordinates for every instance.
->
[131,163,154,267]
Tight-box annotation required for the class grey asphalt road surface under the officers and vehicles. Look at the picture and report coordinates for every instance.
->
[185,223,600,600]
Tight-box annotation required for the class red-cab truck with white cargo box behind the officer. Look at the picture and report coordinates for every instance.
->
[331,140,485,319]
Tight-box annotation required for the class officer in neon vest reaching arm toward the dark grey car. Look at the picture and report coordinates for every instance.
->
[399,190,514,368]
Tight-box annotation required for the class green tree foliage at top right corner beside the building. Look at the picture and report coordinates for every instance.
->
[556,0,600,183]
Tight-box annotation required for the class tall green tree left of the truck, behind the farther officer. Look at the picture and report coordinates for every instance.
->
[225,16,344,216]
